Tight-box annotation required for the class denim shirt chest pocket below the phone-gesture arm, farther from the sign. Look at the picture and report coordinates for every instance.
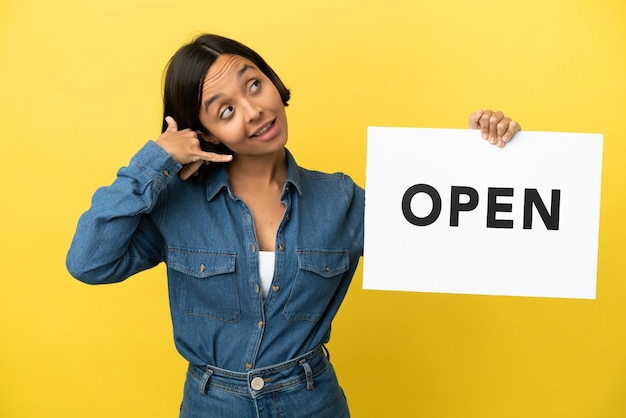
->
[167,248,241,323]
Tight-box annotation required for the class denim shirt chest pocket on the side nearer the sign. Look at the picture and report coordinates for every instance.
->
[284,250,350,322]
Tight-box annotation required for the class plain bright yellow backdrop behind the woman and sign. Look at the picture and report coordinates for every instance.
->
[0,0,626,418]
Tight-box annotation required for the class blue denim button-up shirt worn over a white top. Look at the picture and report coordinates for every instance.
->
[67,141,365,372]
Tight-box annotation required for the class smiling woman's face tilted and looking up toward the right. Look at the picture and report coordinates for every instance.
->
[200,55,287,155]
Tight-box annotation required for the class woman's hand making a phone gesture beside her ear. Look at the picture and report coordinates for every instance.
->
[156,116,233,180]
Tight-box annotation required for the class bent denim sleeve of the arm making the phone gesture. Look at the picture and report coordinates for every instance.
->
[66,141,182,284]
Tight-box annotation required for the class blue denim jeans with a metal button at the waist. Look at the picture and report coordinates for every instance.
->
[180,346,350,418]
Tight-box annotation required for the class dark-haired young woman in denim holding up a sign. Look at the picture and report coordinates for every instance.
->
[67,35,520,418]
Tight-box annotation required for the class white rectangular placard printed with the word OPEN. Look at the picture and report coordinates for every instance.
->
[363,127,603,299]
